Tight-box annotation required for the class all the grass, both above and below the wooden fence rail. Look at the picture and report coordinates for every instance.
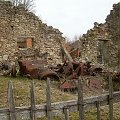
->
[0,76,120,120]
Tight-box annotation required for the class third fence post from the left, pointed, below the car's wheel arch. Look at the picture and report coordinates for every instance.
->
[46,78,52,120]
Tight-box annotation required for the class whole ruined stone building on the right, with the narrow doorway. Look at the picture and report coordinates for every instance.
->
[80,3,120,69]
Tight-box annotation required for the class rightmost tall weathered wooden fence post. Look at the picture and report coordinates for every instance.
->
[109,74,113,120]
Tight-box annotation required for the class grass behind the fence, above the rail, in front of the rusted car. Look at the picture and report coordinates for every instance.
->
[0,76,77,108]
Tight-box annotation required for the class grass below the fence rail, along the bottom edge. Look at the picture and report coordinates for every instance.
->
[38,103,120,120]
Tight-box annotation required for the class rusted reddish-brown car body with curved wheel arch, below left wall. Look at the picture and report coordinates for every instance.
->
[18,60,59,79]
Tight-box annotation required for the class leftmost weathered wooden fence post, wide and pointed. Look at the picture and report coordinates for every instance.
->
[8,81,16,120]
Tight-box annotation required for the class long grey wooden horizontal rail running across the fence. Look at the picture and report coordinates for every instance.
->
[0,91,120,120]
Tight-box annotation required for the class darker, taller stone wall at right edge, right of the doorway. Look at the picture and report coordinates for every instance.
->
[106,2,120,70]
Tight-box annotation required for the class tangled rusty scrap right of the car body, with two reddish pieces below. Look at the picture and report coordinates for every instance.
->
[56,61,102,90]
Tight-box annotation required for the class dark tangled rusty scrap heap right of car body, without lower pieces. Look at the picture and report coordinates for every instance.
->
[56,62,102,79]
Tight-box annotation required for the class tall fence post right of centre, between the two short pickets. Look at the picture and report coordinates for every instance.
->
[78,77,84,120]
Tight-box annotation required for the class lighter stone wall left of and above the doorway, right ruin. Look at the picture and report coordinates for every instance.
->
[80,22,109,64]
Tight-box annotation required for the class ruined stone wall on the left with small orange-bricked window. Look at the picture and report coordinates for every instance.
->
[0,1,64,64]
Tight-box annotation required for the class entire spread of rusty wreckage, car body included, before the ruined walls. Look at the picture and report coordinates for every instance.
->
[0,56,102,91]
